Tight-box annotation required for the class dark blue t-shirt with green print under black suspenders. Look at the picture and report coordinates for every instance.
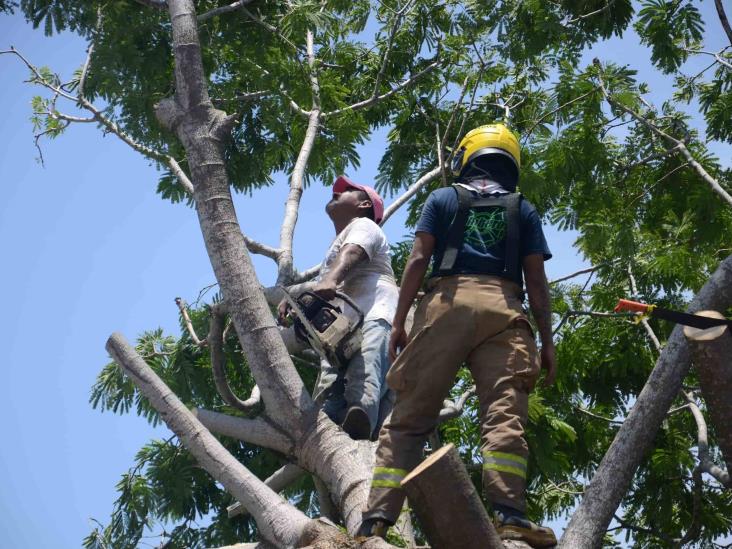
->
[415,187,552,276]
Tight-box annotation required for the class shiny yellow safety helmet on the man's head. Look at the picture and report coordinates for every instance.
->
[452,124,521,177]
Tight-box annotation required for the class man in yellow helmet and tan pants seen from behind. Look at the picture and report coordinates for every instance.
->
[359,124,556,547]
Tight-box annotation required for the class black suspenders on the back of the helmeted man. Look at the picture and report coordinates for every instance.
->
[438,185,523,286]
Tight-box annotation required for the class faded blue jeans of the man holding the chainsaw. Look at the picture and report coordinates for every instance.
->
[313,319,393,433]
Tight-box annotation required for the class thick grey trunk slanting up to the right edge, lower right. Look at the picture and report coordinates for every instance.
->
[559,256,732,549]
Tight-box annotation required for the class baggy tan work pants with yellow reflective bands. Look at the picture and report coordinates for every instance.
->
[364,275,540,522]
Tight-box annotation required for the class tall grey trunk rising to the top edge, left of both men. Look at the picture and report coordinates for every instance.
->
[157,0,317,437]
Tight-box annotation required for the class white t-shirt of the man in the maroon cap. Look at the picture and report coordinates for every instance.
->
[318,217,399,324]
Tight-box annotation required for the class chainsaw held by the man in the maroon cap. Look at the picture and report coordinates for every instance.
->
[282,288,363,369]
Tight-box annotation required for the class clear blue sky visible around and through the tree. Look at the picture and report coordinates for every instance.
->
[0,2,729,548]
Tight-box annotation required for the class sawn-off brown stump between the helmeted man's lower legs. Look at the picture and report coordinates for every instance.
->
[402,444,503,549]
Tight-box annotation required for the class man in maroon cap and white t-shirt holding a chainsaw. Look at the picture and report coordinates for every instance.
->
[279,176,399,440]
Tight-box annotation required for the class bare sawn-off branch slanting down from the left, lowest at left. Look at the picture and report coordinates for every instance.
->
[107,334,309,546]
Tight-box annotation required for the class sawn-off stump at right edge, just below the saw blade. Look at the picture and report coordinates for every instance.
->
[684,311,732,478]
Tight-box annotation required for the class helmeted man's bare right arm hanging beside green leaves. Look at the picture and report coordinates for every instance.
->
[523,254,557,385]
